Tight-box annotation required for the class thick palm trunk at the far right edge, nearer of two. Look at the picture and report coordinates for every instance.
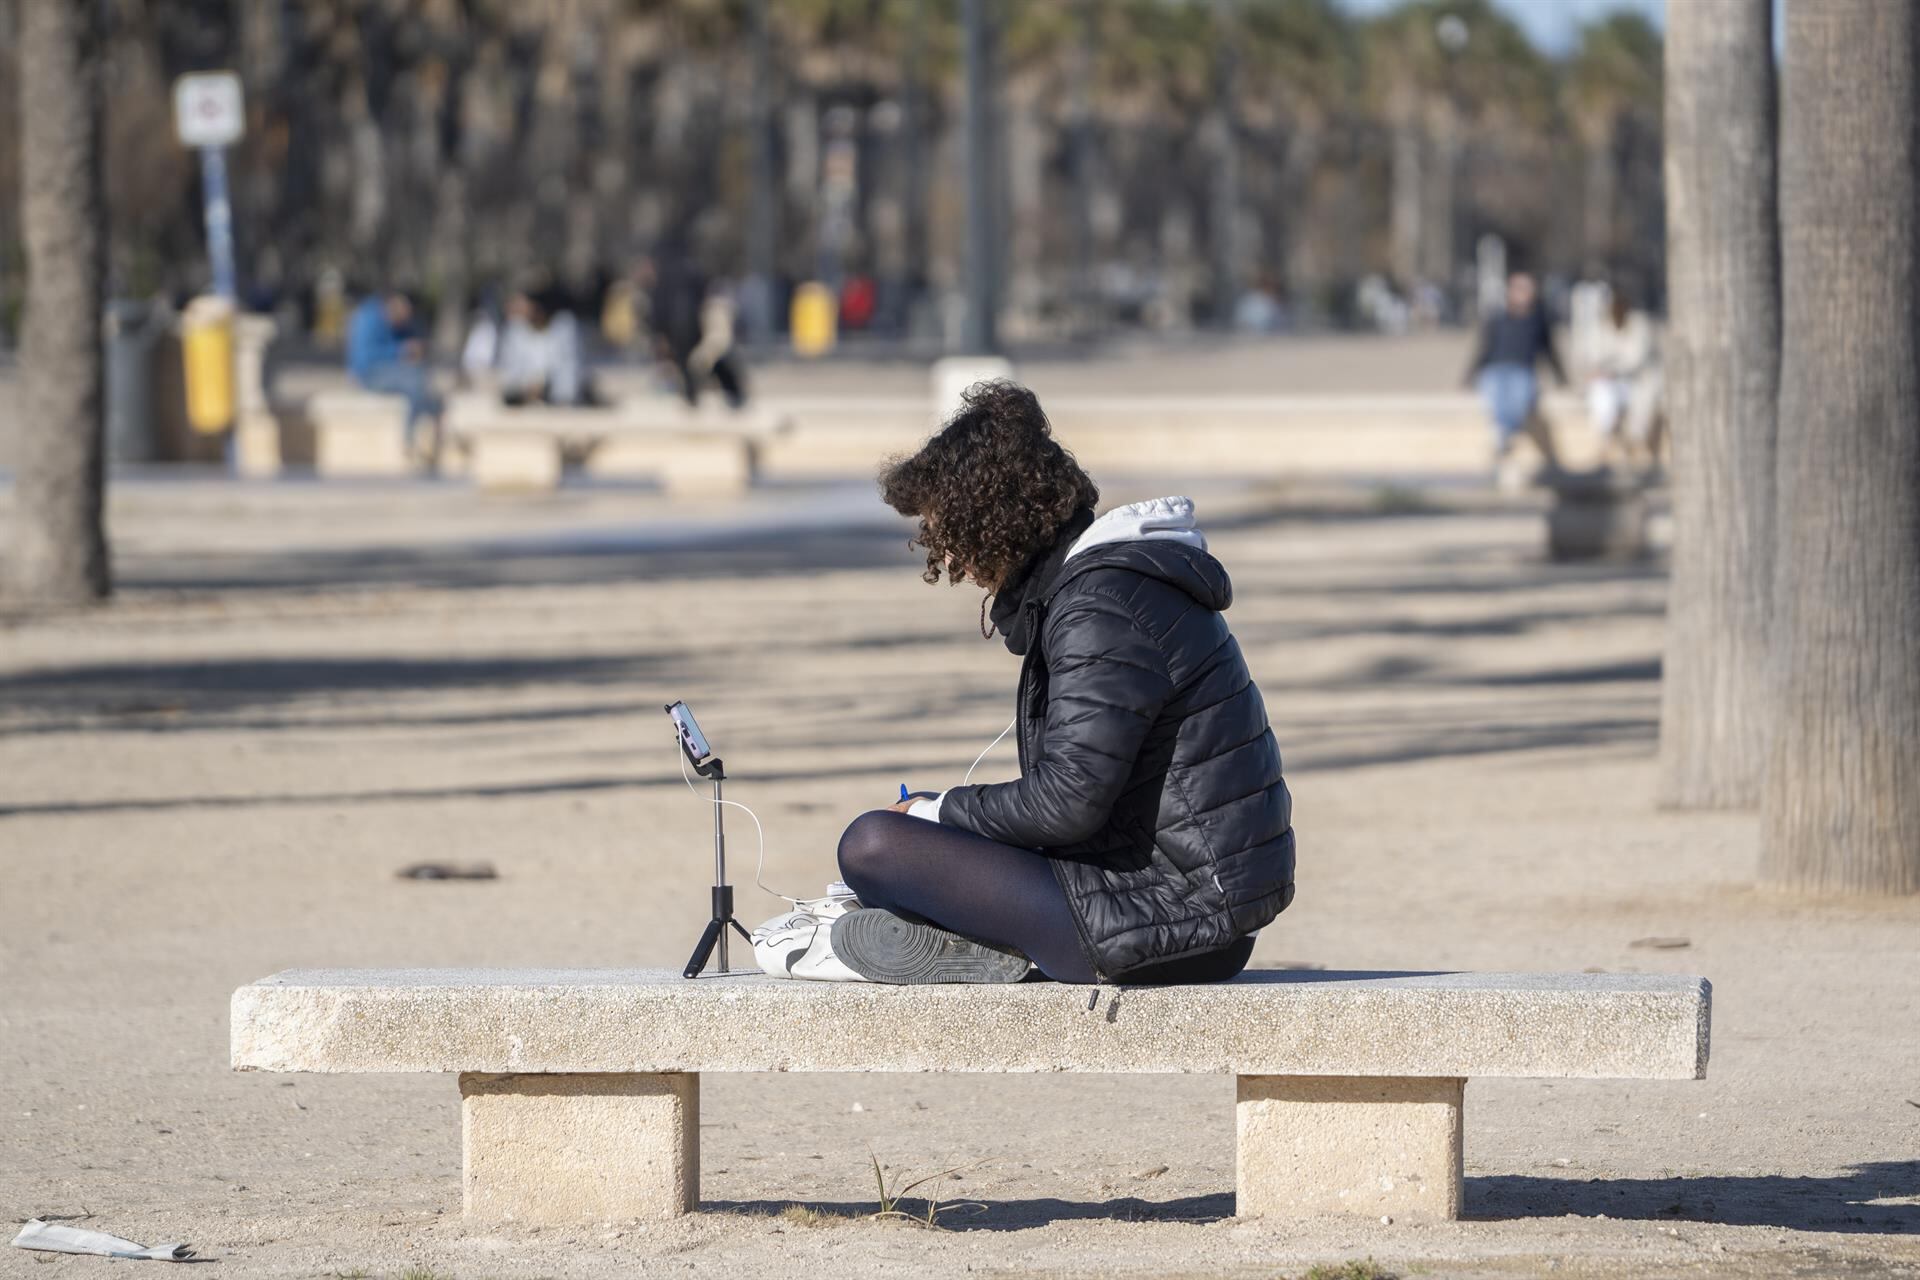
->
[1758,0,1920,894]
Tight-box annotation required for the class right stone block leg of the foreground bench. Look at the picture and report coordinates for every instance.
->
[1236,1075,1467,1219]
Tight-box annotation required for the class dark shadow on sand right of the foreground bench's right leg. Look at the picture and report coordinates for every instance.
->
[1467,1161,1920,1234]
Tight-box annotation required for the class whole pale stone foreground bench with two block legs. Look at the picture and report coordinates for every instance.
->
[232,969,1711,1222]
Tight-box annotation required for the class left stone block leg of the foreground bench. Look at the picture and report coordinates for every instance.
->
[461,1073,701,1224]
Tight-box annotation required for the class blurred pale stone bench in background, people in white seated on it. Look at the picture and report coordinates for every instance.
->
[447,395,785,497]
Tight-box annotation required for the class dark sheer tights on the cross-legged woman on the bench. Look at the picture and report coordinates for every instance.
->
[839,810,1254,983]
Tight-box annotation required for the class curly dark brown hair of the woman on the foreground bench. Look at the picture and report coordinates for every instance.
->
[879,380,1100,591]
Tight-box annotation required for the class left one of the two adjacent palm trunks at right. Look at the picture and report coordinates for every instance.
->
[1659,0,1780,808]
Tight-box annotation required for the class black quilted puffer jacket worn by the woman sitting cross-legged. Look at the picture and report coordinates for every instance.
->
[941,522,1294,981]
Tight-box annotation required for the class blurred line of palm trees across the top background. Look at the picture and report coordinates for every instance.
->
[0,0,1663,340]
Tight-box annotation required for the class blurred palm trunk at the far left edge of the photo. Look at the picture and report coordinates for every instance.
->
[6,4,109,604]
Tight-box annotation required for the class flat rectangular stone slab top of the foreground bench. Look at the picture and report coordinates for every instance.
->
[232,969,1711,1079]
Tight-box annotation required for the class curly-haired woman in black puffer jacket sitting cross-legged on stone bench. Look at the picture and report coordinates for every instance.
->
[756,382,1294,983]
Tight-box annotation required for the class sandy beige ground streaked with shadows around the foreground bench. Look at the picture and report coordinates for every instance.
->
[0,482,1920,1280]
